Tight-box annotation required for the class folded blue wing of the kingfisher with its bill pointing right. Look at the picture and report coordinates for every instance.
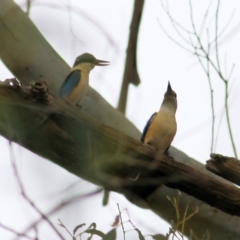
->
[58,70,81,97]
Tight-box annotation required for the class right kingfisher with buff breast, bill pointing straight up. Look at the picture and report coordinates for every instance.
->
[141,82,177,155]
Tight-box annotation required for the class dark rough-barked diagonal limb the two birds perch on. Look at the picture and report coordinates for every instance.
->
[0,83,240,229]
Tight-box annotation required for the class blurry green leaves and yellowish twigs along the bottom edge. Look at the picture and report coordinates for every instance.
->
[59,196,206,240]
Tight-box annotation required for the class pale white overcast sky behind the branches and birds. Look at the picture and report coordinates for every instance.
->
[0,0,240,239]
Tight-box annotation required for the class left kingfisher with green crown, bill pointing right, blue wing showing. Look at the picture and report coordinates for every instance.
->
[59,53,109,104]
